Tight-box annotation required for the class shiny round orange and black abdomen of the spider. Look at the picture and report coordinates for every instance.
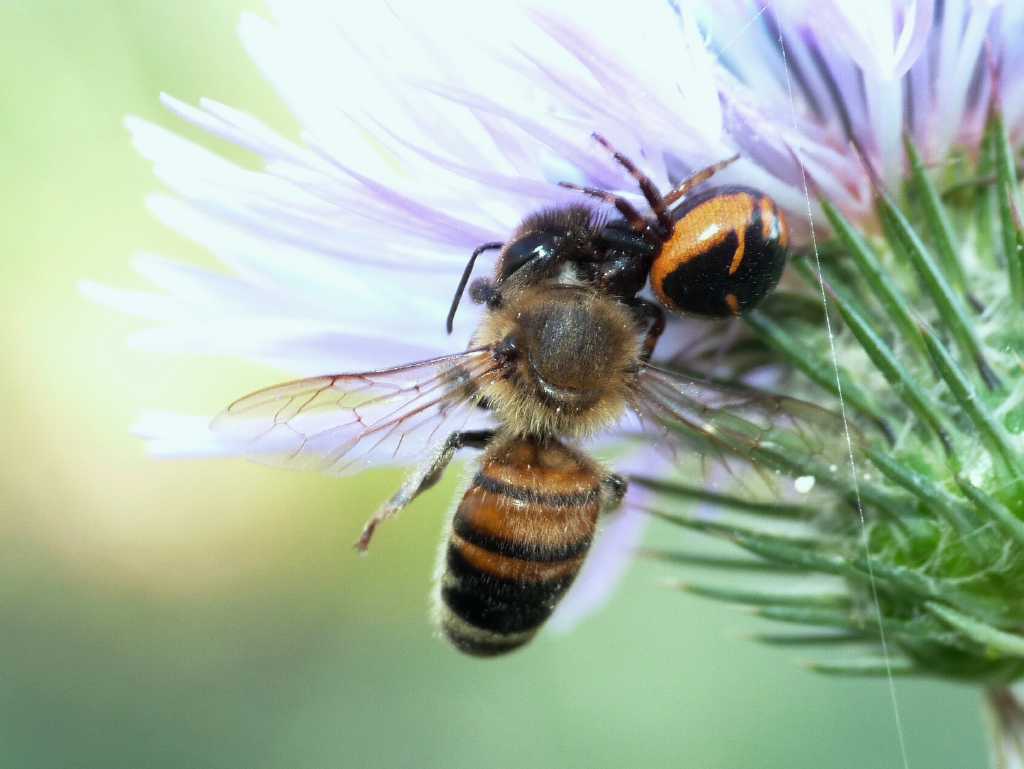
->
[650,186,788,317]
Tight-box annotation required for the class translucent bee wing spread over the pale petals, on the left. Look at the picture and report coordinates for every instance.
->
[211,348,498,475]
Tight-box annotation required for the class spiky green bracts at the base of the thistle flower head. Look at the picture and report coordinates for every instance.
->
[640,112,1024,692]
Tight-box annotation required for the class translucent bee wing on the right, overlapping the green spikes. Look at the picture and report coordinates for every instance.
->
[633,366,862,484]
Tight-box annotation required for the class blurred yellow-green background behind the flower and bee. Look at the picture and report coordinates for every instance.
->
[0,0,986,769]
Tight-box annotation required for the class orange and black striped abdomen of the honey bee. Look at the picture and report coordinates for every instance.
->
[440,438,604,656]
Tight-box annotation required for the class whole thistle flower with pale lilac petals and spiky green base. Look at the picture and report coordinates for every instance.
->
[85,0,1024,765]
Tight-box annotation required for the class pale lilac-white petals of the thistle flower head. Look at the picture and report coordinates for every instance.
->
[90,0,1024,628]
